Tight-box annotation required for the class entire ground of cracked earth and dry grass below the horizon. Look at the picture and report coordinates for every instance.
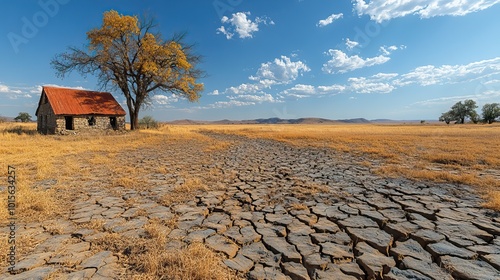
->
[0,124,500,279]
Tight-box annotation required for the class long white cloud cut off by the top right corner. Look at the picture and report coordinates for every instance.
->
[353,0,500,23]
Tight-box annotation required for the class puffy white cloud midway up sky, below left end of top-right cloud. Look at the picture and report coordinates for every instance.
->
[322,49,390,74]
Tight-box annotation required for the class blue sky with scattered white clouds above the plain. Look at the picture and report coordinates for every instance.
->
[0,0,500,120]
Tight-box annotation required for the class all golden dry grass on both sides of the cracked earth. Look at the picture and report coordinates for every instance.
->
[0,123,500,279]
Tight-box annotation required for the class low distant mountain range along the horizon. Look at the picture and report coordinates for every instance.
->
[167,118,430,124]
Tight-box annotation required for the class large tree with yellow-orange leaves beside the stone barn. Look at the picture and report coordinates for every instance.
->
[51,11,203,130]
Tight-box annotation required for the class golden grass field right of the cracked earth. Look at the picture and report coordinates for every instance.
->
[196,124,500,210]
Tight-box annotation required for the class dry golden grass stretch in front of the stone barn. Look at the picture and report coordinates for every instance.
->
[0,123,232,279]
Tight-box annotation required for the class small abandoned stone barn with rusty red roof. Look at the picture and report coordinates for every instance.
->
[35,86,126,134]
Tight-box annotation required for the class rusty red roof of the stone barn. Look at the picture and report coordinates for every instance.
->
[37,86,126,116]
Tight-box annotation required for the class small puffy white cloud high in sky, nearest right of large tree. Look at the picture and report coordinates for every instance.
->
[217,12,274,40]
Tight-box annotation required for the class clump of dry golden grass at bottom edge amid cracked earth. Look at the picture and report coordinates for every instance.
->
[88,220,239,280]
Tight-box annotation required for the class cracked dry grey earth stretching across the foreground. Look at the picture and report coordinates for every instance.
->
[0,132,500,279]
